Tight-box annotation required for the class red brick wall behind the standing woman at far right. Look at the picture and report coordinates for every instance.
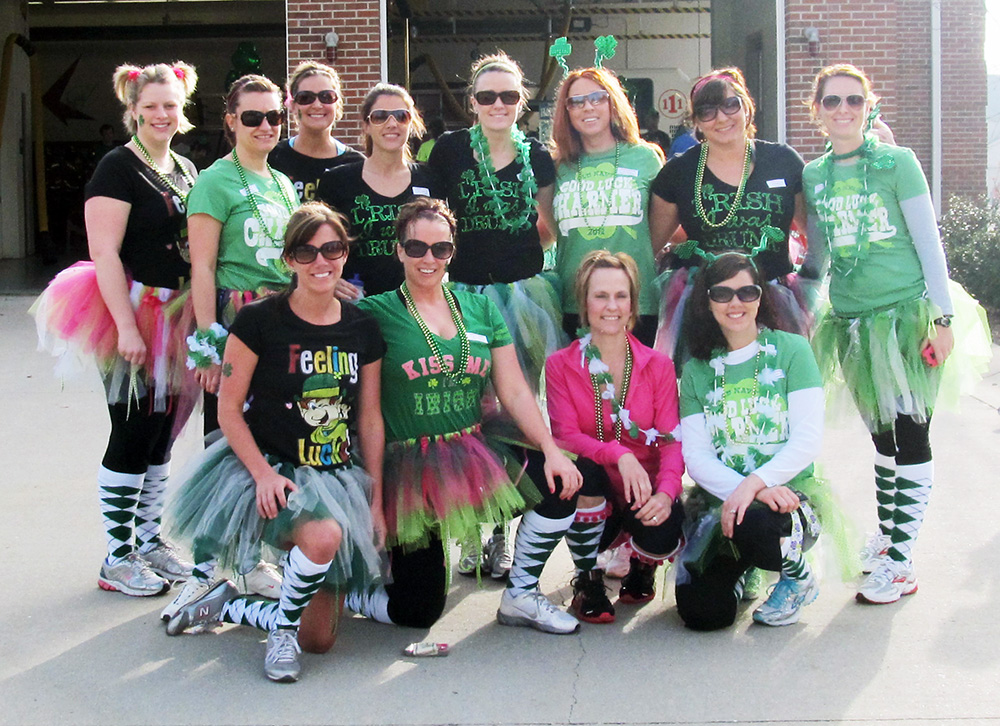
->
[785,0,986,201]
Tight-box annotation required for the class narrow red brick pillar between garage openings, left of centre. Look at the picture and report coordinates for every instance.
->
[285,0,381,145]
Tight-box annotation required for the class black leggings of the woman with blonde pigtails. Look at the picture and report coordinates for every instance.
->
[101,396,177,474]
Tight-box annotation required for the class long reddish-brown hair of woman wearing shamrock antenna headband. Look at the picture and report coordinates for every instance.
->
[551,68,664,165]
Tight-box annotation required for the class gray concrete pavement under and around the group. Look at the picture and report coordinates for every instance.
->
[0,296,1000,726]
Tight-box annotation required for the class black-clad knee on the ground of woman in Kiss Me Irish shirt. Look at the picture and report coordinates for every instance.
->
[385,538,447,628]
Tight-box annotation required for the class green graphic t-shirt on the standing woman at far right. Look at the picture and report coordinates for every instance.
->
[802,144,928,316]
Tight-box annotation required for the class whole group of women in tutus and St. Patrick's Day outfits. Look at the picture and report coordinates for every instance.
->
[36,48,992,681]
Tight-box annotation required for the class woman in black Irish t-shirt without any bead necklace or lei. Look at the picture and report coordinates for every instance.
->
[318,83,439,300]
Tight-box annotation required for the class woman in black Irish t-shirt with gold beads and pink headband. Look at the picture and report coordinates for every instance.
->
[649,68,811,370]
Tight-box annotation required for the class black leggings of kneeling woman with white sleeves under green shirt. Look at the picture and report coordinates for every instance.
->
[676,503,792,630]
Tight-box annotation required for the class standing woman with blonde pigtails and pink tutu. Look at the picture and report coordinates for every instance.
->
[33,62,197,596]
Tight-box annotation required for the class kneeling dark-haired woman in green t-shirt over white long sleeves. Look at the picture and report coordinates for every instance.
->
[676,247,831,630]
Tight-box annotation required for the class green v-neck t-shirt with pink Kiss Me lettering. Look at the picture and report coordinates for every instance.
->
[358,290,511,441]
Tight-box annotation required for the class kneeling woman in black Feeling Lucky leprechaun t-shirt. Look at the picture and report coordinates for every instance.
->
[167,202,385,681]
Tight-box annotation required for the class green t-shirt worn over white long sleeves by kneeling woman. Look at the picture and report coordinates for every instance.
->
[680,330,823,474]
